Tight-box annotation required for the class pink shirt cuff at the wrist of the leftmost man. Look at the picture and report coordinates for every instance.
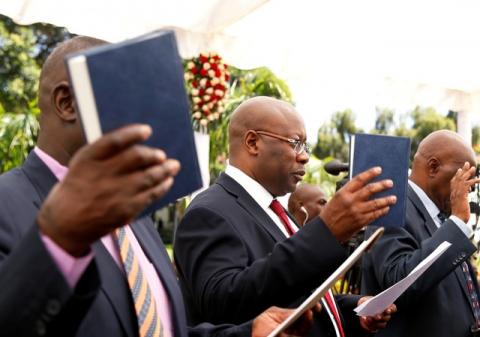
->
[41,234,94,289]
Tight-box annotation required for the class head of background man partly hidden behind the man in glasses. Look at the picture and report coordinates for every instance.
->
[288,184,327,226]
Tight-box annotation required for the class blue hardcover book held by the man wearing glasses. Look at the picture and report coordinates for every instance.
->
[350,134,410,227]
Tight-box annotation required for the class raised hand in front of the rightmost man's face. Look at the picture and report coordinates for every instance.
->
[450,161,480,223]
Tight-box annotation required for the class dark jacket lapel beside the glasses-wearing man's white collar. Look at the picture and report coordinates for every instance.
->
[216,173,285,242]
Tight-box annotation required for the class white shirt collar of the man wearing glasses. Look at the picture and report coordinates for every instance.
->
[225,165,298,237]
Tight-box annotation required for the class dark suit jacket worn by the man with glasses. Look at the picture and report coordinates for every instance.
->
[174,174,358,336]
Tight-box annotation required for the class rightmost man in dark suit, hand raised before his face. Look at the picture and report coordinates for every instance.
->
[362,130,479,337]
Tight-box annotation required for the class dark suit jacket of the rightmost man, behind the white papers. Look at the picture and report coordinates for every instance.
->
[362,186,478,337]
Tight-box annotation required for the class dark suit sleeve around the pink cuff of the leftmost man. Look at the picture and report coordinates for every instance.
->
[0,213,100,336]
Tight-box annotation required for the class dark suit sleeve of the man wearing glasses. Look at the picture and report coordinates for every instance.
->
[175,207,345,323]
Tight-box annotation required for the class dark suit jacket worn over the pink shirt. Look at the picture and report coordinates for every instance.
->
[0,152,251,337]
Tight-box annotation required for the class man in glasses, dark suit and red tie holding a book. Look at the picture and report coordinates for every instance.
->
[174,97,395,336]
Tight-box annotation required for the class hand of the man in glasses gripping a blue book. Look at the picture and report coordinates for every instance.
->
[320,167,397,242]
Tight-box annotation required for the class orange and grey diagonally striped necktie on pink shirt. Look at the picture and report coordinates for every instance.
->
[116,227,163,337]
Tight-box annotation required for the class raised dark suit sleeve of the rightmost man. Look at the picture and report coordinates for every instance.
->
[364,220,475,305]
